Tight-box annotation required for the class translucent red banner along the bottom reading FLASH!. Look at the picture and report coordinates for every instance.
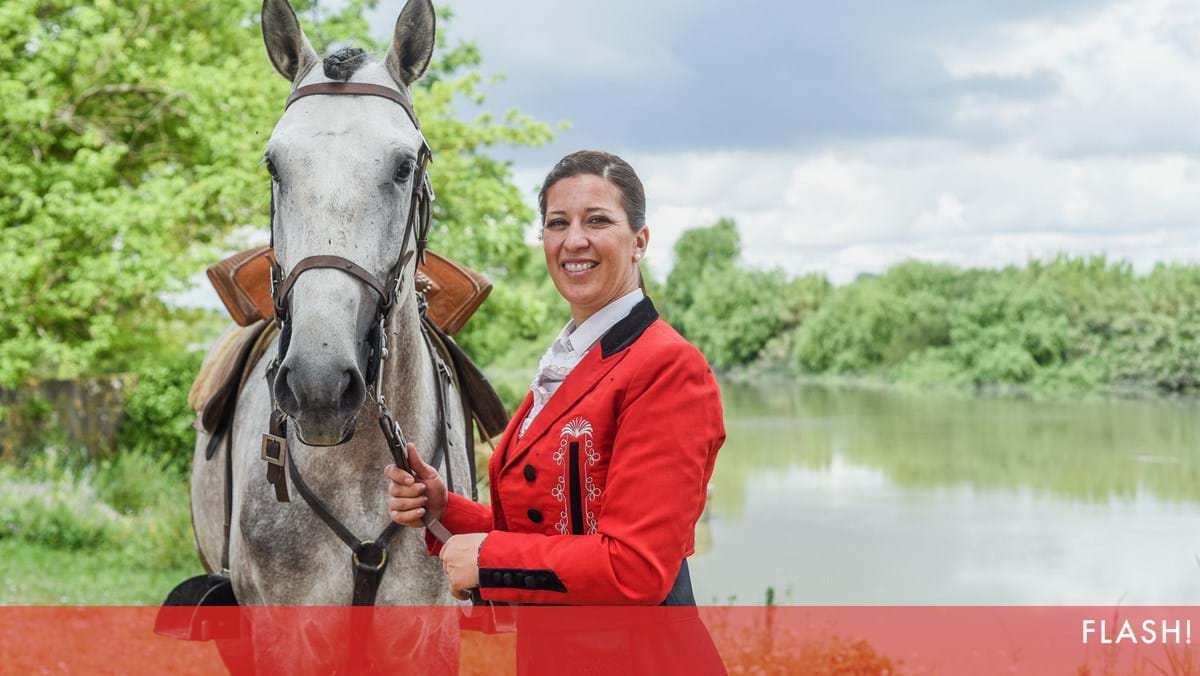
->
[0,606,1200,675]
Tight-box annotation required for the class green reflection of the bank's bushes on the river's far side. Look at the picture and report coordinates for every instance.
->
[713,383,1200,515]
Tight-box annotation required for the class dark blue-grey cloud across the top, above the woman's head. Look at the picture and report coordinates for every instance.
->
[373,0,1096,154]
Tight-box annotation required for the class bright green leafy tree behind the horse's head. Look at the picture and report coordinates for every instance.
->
[0,0,551,385]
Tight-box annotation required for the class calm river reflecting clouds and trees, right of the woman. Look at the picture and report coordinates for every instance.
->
[690,383,1200,605]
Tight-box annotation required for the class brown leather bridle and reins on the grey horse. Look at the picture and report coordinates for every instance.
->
[250,82,456,605]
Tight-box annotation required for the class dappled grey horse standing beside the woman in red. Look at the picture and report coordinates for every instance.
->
[191,0,474,674]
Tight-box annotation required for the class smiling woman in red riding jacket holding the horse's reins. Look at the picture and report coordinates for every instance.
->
[386,151,725,667]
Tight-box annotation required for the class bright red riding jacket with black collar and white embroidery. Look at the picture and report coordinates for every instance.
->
[426,298,725,605]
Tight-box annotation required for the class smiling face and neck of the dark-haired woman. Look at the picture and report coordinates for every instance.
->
[541,174,650,325]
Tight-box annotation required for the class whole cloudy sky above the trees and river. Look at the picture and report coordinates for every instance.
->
[372,0,1200,282]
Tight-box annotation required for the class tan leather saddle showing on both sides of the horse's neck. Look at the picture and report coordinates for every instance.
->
[208,246,492,335]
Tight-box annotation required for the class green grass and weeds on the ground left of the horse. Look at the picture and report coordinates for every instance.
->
[0,448,203,605]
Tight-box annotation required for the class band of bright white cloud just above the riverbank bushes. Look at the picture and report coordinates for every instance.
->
[634,142,1200,282]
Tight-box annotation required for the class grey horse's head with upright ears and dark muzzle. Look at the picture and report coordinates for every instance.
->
[263,0,434,444]
